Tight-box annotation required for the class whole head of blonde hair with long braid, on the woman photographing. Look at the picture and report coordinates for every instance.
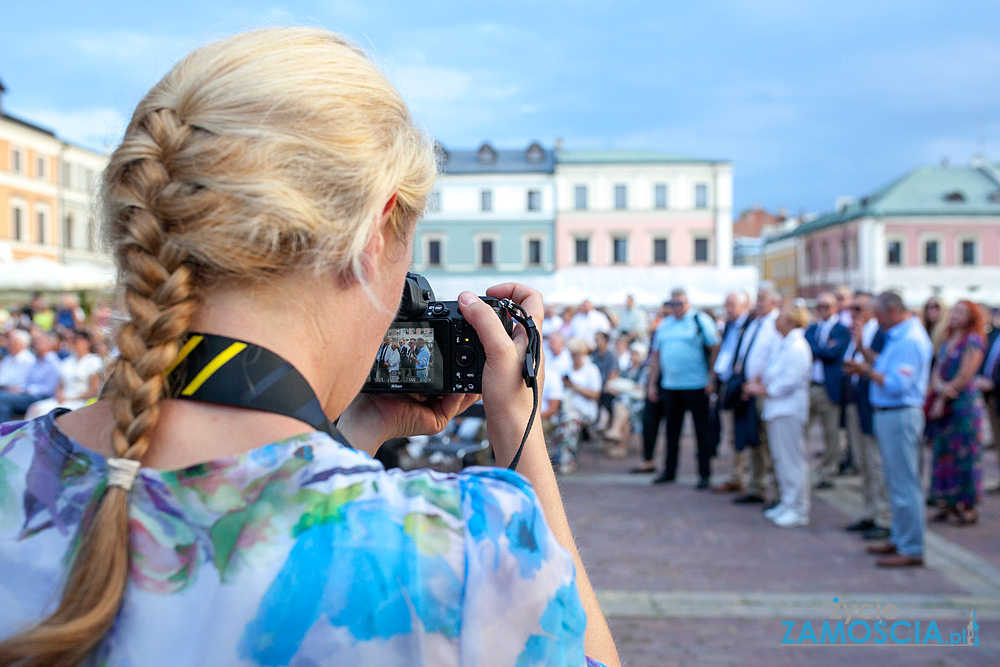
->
[0,28,436,665]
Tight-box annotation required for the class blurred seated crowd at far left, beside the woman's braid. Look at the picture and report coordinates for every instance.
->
[0,294,112,422]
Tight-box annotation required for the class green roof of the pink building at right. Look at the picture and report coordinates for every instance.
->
[768,159,1000,242]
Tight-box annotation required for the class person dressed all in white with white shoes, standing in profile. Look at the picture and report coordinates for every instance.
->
[744,305,813,528]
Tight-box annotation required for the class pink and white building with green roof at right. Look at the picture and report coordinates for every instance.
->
[765,158,1000,305]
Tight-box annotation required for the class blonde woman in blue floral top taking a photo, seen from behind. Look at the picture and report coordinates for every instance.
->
[0,29,618,666]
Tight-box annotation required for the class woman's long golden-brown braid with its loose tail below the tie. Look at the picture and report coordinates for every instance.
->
[0,109,197,667]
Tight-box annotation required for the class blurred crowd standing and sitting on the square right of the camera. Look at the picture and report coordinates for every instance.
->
[541,285,1000,567]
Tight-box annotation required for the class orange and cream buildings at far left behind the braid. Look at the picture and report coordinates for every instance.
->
[0,84,109,265]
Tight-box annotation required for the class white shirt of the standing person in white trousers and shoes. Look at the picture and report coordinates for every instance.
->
[761,329,812,422]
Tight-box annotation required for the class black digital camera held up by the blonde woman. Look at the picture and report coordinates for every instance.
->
[361,273,514,394]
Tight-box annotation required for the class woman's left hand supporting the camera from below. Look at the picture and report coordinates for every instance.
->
[337,394,479,456]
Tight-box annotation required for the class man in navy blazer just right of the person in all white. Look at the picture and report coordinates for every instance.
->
[806,292,851,489]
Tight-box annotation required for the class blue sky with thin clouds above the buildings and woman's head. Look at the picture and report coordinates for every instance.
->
[0,0,1000,215]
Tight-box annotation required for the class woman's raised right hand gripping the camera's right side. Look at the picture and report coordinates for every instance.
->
[458,283,545,465]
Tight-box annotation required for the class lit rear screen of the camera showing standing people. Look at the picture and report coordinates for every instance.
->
[365,321,447,393]
